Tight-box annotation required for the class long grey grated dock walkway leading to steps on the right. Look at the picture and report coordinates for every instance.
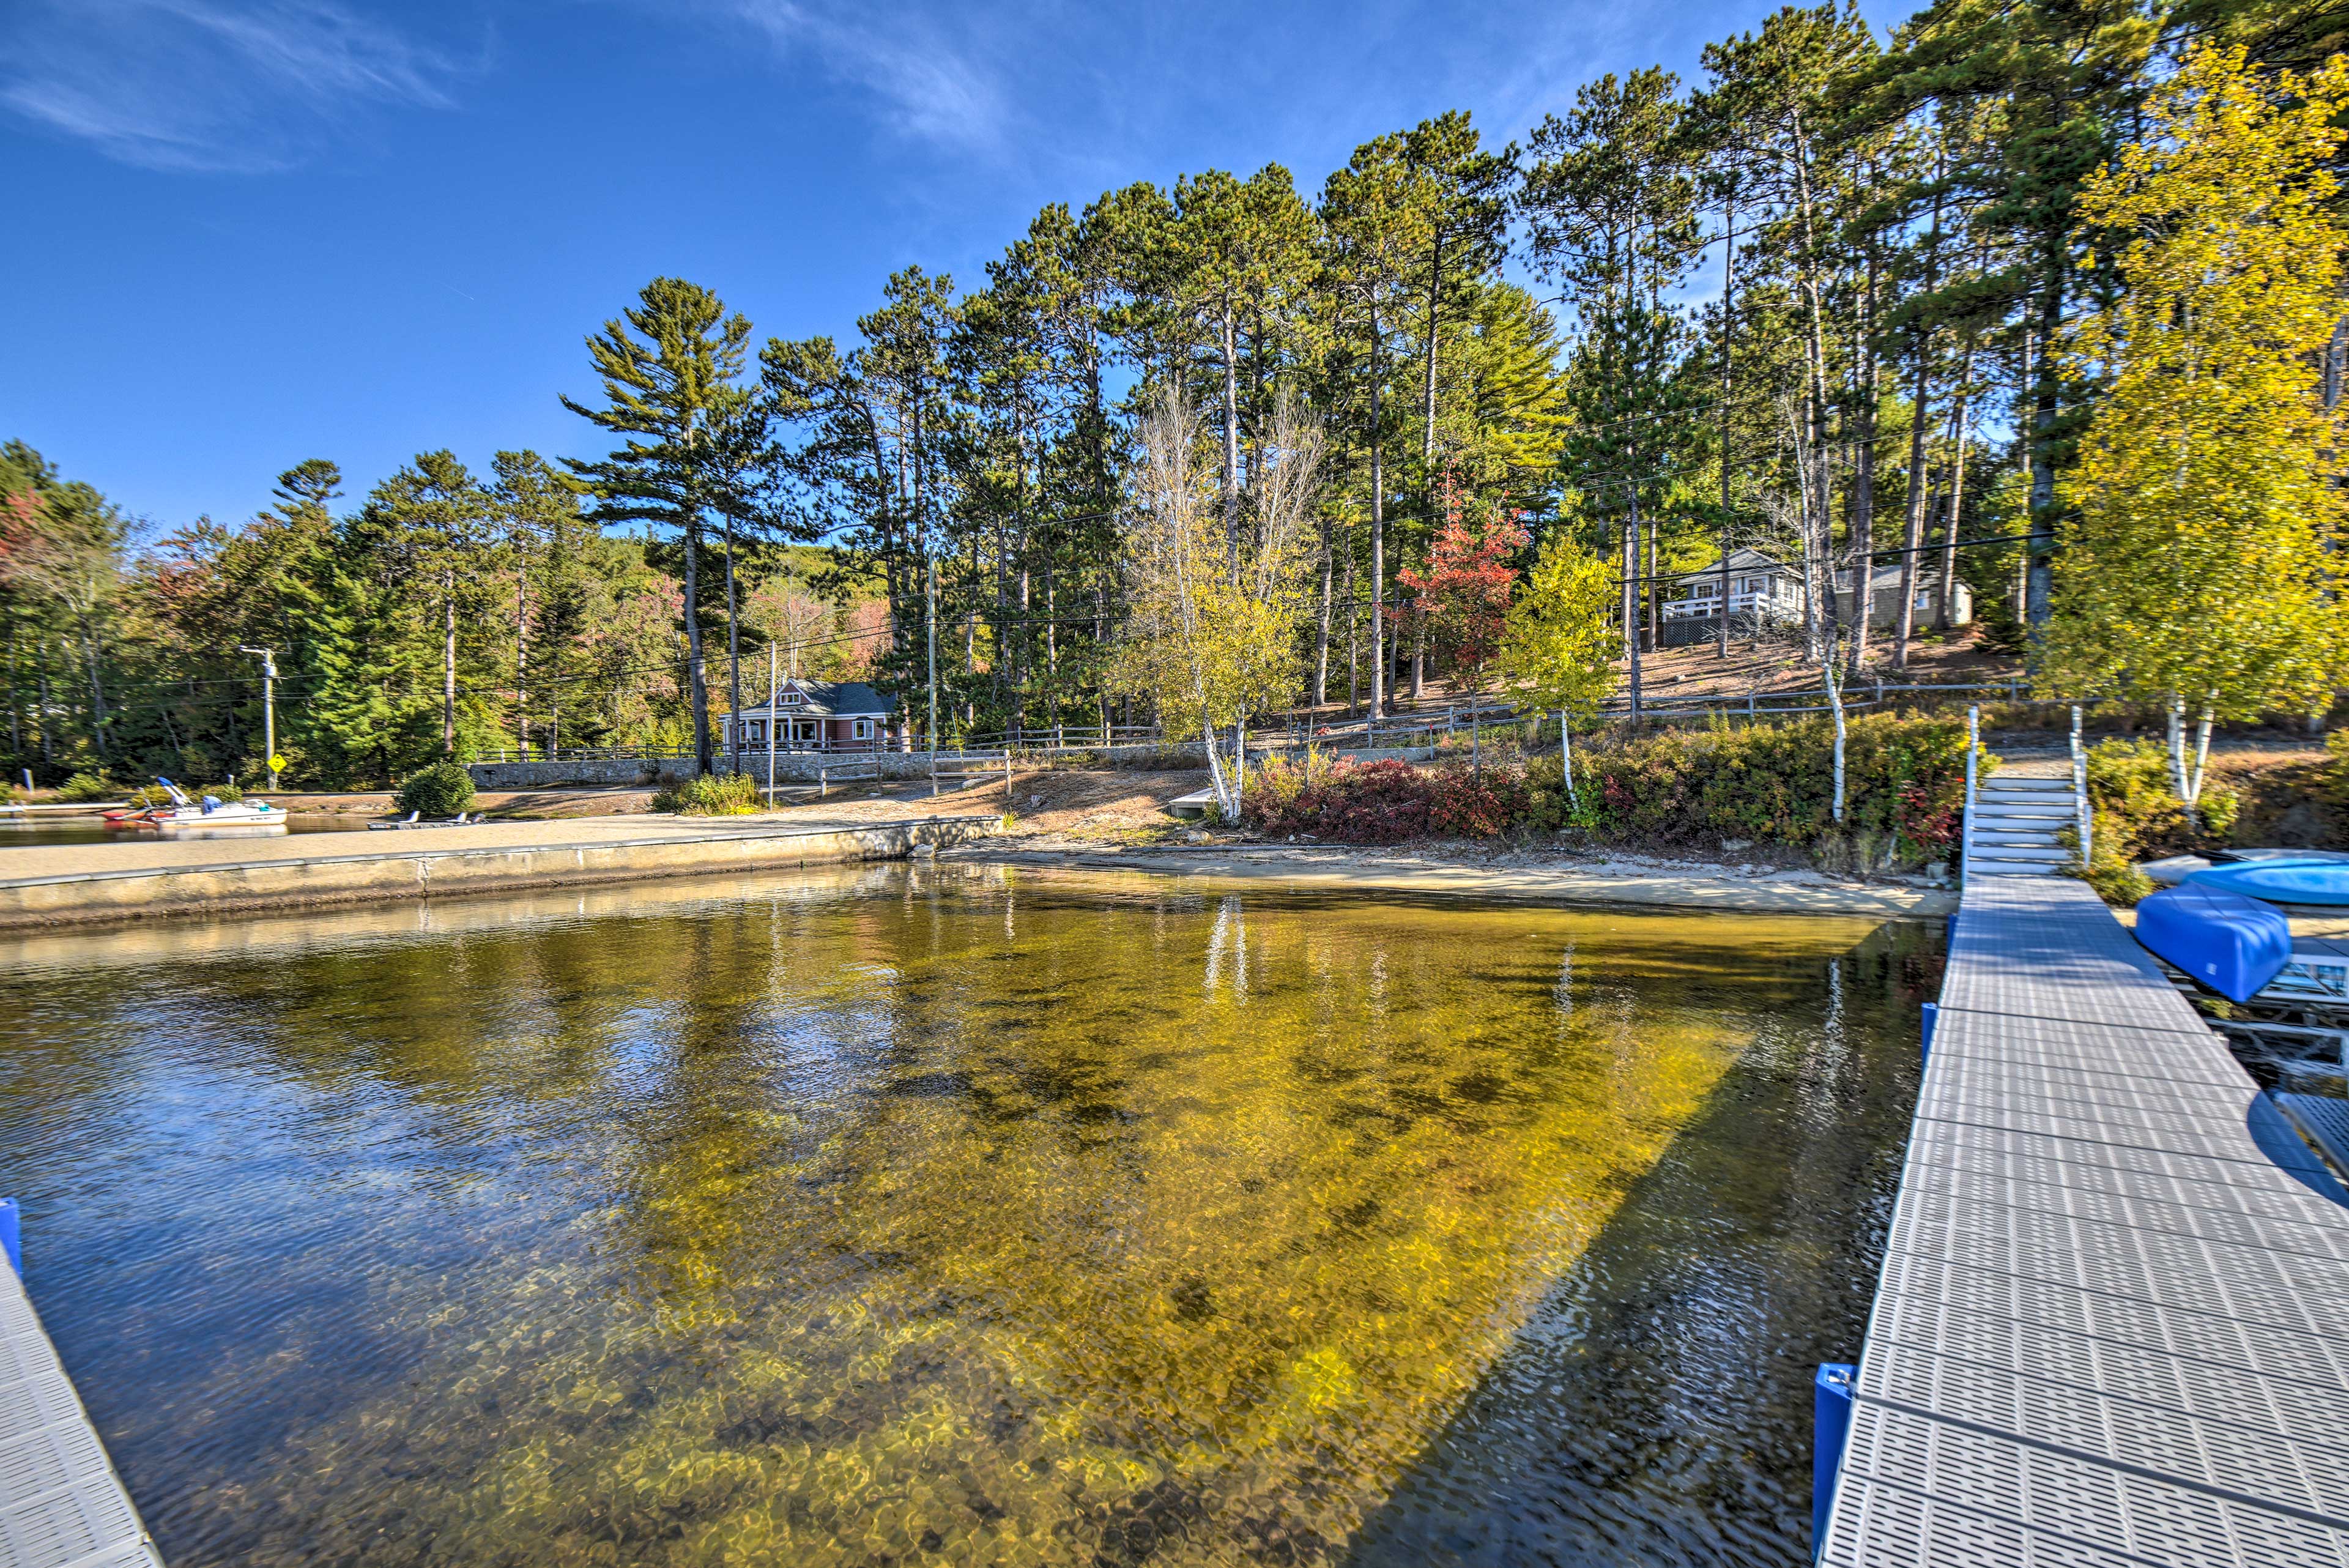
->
[1820,877,2349,1568]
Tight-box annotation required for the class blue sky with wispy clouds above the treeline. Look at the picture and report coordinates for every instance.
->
[0,0,1887,529]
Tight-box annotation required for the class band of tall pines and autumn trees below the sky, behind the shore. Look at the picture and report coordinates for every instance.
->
[0,0,2342,785]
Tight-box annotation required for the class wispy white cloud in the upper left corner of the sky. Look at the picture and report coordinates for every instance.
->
[0,0,462,172]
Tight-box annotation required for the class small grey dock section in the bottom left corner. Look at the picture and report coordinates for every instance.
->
[0,1258,162,1568]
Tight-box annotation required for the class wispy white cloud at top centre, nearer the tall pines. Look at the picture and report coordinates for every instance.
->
[719,0,1012,150]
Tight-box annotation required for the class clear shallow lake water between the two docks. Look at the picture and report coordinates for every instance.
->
[0,868,1940,1568]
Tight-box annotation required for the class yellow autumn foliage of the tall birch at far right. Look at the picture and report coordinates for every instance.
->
[2039,47,2349,719]
